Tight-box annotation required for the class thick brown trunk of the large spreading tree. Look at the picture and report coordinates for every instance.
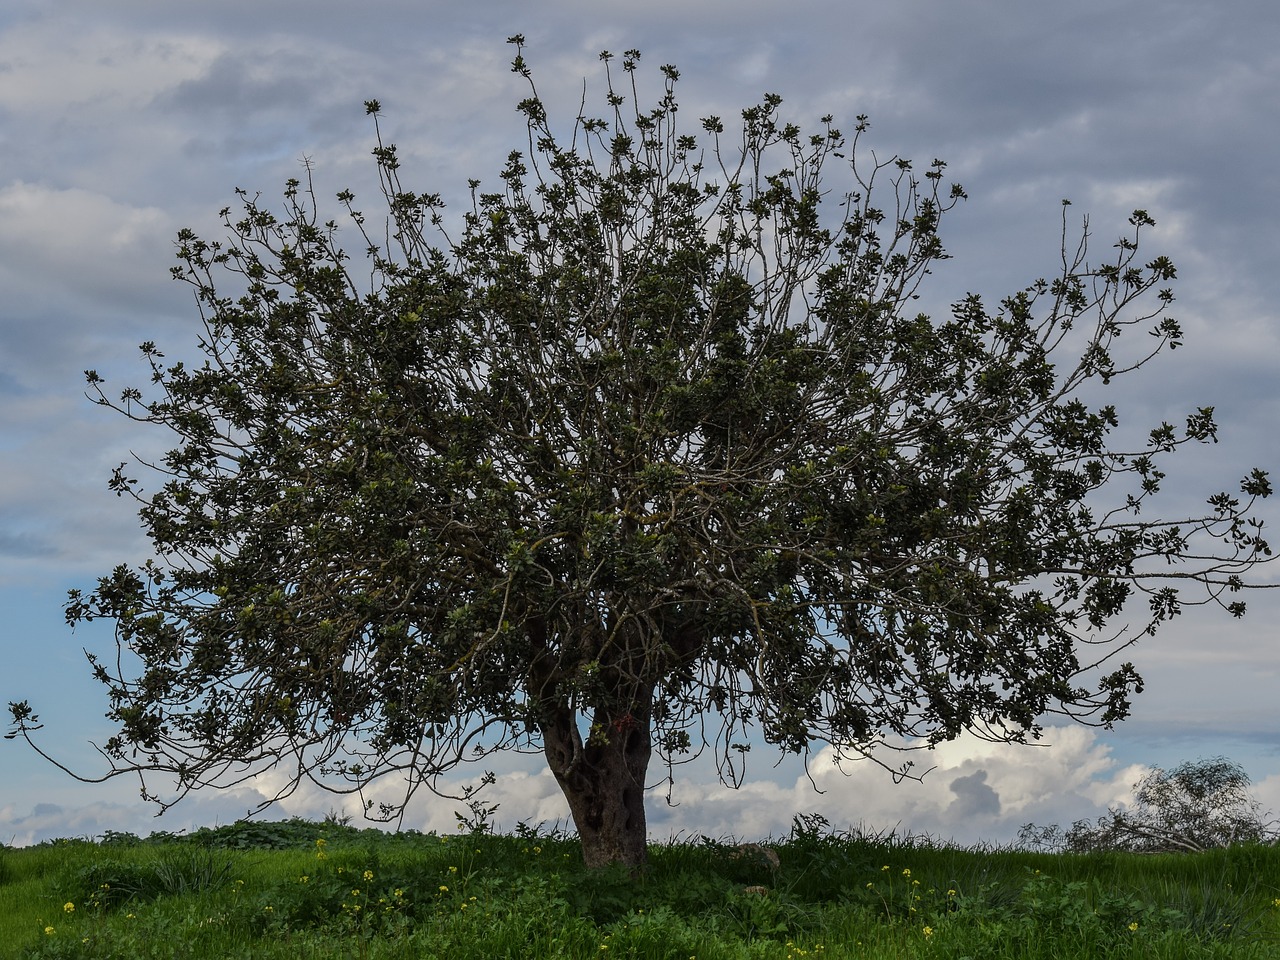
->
[543,695,653,870]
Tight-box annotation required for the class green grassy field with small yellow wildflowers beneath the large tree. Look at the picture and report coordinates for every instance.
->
[0,818,1280,960]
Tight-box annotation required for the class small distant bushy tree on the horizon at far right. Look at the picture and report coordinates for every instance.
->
[1065,756,1276,852]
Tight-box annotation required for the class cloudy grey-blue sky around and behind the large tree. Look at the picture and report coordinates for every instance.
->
[0,0,1280,845]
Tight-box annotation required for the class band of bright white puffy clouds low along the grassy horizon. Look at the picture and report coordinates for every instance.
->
[0,727,1141,845]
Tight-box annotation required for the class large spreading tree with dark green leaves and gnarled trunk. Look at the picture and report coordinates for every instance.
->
[13,37,1271,865]
